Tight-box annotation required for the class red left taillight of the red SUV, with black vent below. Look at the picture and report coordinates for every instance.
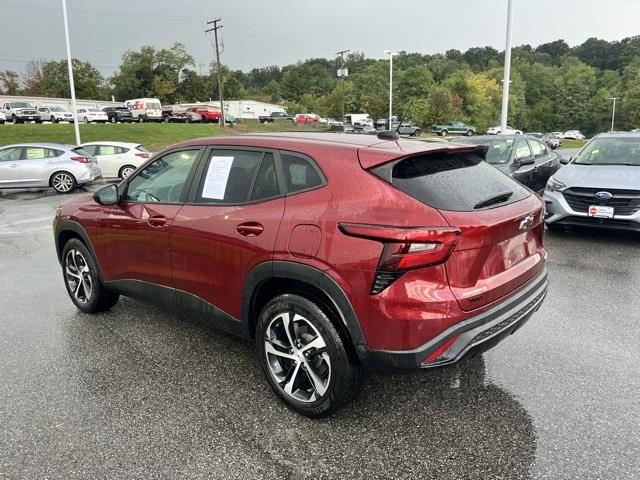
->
[339,223,460,295]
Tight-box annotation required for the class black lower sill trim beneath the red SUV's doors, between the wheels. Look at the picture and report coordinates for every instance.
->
[105,280,246,338]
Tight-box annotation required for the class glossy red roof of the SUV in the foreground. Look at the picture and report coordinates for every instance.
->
[164,132,484,168]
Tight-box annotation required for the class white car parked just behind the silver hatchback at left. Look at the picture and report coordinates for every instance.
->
[79,142,151,179]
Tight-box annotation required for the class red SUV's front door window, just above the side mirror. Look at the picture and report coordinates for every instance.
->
[124,149,200,203]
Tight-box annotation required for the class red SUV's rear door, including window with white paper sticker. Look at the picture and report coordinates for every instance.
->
[171,147,284,318]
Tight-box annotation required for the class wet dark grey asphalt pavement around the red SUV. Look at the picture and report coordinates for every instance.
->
[0,181,640,480]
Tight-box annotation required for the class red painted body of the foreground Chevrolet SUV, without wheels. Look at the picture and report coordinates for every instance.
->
[54,133,547,371]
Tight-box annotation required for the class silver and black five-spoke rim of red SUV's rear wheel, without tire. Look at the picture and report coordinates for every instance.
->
[264,312,331,403]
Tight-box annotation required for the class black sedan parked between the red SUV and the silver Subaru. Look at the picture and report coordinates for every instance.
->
[455,135,560,192]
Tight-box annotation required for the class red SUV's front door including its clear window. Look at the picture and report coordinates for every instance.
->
[92,147,203,288]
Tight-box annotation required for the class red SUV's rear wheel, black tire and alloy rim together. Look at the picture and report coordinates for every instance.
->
[256,294,363,418]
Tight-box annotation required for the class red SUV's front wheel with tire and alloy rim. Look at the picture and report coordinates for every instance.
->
[62,238,120,313]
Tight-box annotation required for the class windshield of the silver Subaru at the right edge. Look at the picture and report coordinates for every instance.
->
[573,137,640,166]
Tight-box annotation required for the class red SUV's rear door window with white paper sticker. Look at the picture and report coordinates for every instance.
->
[197,150,265,204]
